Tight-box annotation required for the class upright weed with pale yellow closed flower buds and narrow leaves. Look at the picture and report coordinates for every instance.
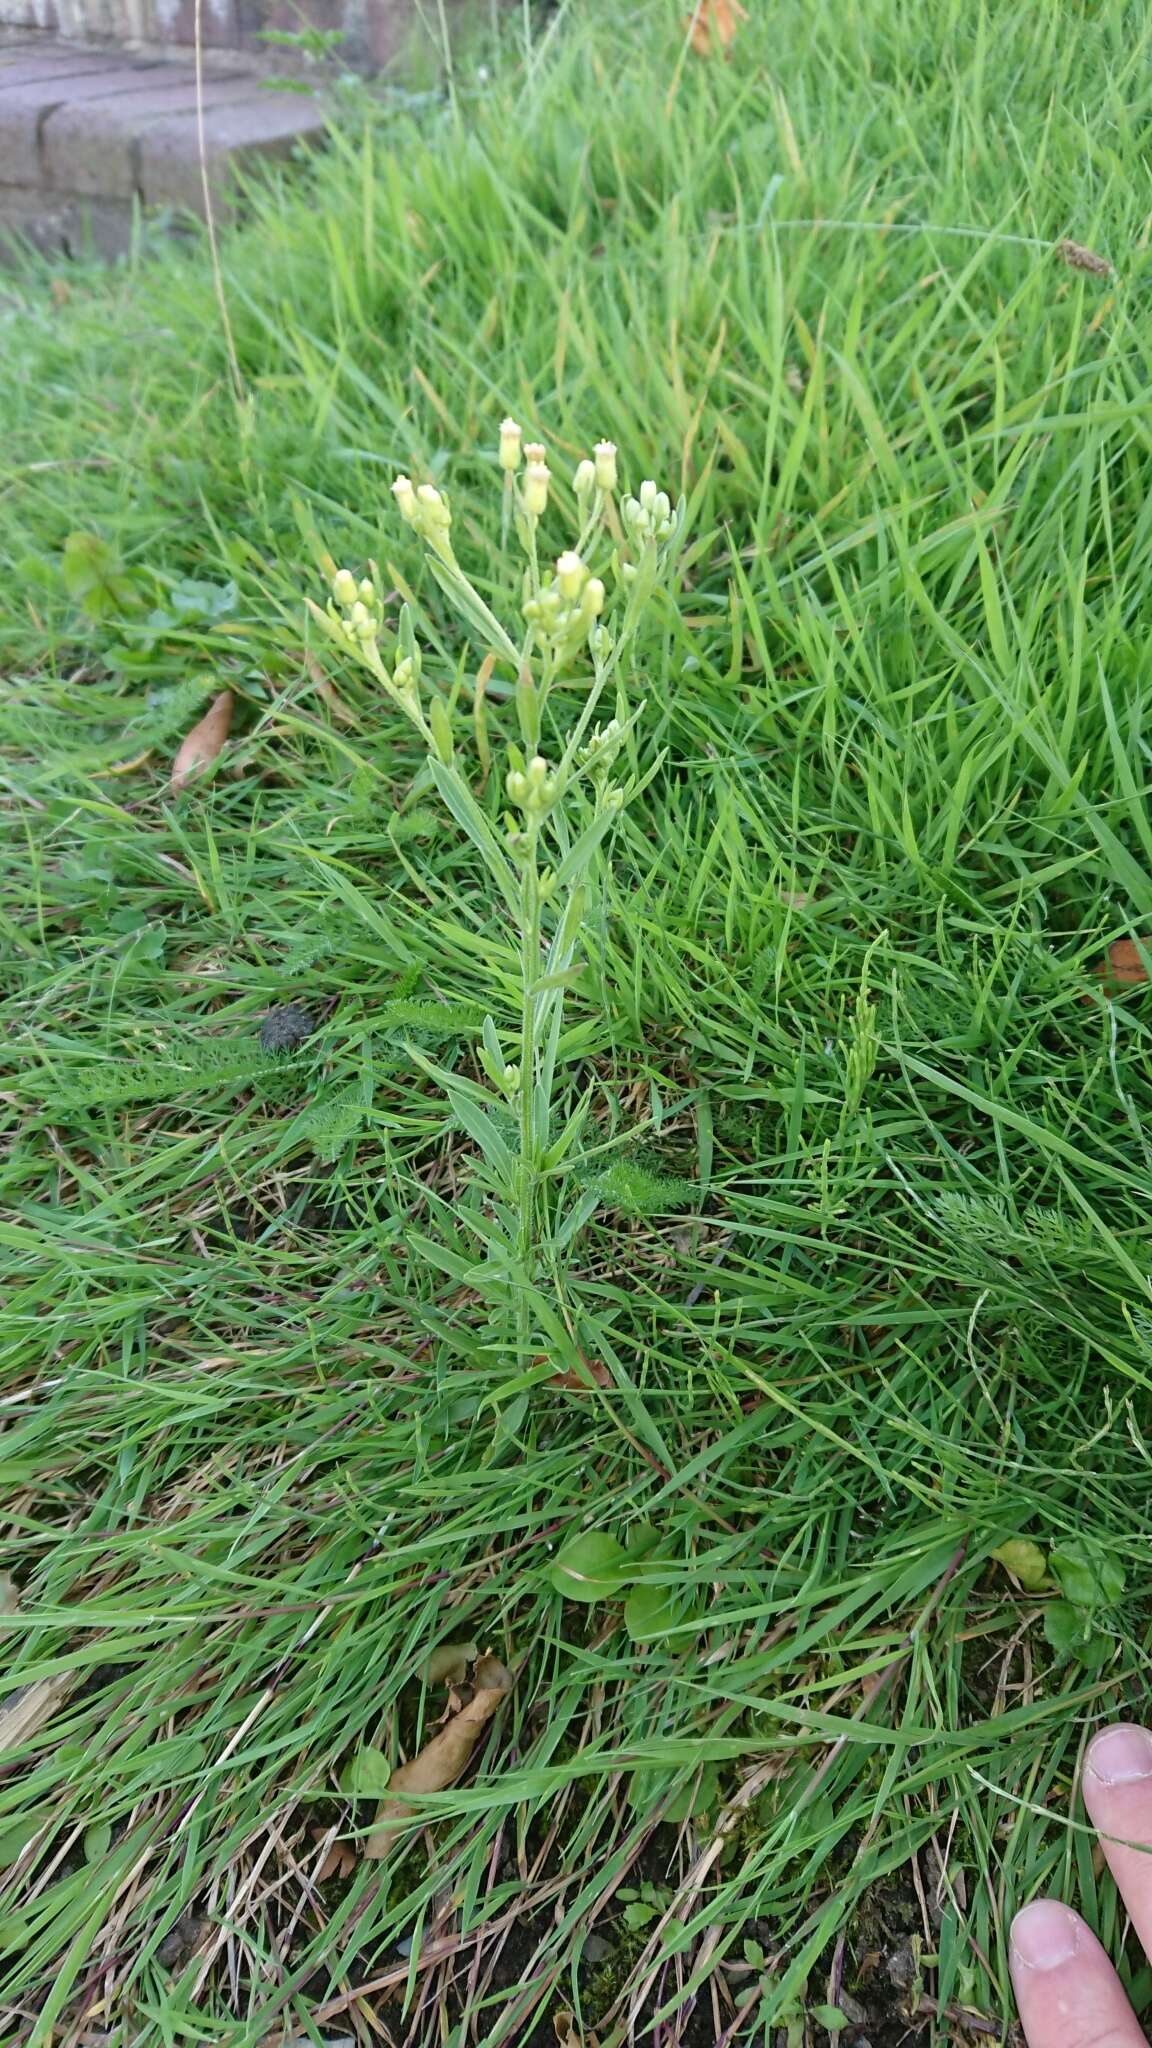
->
[310,420,685,1368]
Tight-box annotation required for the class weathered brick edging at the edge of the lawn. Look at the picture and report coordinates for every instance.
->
[0,41,324,256]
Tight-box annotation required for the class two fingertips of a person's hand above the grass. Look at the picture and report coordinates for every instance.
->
[1011,1724,1152,2048]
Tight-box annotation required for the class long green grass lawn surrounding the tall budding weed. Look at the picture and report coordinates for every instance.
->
[0,0,1152,2048]
